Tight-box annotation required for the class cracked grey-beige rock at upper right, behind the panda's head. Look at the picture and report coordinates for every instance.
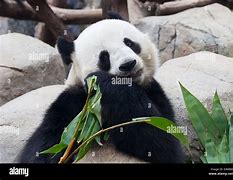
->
[135,4,233,63]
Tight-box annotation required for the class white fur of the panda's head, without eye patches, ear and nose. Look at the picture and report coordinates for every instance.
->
[66,19,159,85]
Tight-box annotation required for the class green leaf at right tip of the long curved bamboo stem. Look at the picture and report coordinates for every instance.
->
[133,117,189,147]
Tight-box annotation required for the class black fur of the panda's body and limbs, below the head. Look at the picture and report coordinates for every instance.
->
[20,71,183,163]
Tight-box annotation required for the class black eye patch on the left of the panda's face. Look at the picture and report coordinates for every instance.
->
[98,50,110,71]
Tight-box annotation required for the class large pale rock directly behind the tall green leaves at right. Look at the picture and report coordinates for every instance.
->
[156,52,233,161]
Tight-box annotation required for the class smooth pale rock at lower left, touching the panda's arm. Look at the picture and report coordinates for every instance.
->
[0,85,64,163]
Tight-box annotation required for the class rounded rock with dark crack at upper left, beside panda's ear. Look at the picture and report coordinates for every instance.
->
[0,33,65,105]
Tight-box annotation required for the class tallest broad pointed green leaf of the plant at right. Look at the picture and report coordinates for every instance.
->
[180,83,221,147]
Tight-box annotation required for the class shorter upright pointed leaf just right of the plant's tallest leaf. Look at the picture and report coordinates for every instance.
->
[211,91,228,138]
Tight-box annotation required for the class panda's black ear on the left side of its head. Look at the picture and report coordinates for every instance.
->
[57,37,74,65]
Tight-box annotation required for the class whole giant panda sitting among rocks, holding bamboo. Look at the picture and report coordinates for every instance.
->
[19,13,184,163]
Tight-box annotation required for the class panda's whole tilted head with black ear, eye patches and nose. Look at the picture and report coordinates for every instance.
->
[58,19,159,85]
